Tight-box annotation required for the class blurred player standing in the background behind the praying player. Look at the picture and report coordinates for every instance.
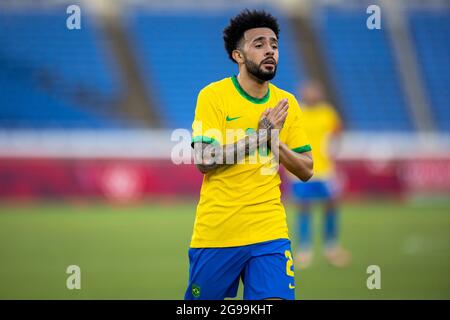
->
[291,82,350,268]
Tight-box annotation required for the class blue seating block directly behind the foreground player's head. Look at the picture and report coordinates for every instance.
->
[127,10,304,128]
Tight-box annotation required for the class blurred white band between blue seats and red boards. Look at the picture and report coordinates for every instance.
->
[0,129,450,160]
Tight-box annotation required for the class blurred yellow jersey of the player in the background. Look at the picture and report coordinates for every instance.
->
[291,102,341,179]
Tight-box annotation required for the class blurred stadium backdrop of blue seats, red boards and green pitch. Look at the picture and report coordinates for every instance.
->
[0,0,450,299]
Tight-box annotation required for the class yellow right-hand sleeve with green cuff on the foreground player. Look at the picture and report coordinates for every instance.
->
[286,97,311,153]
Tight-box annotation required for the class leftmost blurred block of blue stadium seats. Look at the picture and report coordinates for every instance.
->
[0,8,122,128]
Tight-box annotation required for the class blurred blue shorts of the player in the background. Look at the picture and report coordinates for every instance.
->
[291,180,335,201]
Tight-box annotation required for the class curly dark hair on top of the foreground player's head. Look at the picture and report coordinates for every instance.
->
[223,9,280,63]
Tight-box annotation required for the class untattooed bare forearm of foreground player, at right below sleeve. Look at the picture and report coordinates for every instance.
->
[279,142,313,181]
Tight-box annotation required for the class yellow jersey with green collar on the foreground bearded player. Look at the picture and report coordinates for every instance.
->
[191,77,311,248]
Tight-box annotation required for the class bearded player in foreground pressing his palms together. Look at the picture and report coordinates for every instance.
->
[185,10,313,300]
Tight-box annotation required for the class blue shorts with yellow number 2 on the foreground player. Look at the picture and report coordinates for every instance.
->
[184,239,295,300]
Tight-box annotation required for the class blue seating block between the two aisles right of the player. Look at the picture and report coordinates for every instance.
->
[316,7,414,131]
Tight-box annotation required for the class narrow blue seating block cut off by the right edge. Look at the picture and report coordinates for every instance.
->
[409,9,450,131]
